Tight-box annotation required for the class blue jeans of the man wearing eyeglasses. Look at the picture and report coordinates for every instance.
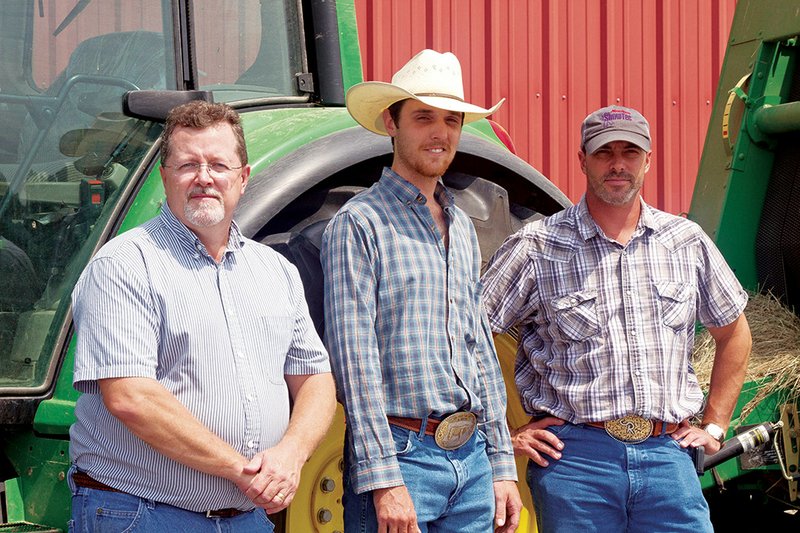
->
[69,472,274,533]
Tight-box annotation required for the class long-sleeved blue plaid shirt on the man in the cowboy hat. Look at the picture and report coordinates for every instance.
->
[322,168,516,493]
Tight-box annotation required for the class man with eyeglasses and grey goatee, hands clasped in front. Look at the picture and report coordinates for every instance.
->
[69,98,335,531]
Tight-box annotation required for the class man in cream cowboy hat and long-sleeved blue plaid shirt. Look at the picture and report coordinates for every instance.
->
[322,50,521,533]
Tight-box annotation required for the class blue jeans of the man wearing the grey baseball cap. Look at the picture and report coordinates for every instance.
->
[527,423,713,533]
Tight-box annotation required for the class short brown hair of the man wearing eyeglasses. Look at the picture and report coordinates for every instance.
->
[161,100,247,165]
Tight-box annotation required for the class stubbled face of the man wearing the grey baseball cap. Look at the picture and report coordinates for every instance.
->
[578,141,650,206]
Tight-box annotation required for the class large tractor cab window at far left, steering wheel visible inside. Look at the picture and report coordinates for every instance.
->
[0,0,169,394]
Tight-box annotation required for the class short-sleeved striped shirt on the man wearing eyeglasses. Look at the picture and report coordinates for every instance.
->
[70,205,330,511]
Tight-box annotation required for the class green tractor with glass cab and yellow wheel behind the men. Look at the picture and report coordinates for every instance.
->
[0,0,569,532]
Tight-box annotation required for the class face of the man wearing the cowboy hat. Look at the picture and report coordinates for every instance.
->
[383,99,462,179]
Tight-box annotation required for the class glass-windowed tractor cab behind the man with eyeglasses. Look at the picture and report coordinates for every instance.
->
[0,0,332,408]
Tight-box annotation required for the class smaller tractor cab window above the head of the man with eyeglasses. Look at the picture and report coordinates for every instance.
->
[194,0,306,102]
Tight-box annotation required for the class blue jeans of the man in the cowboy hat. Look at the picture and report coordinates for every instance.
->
[342,424,494,533]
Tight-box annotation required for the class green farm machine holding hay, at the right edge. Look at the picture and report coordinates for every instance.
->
[690,0,800,531]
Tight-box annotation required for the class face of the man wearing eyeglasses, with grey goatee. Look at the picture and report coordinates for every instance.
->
[161,123,250,233]
